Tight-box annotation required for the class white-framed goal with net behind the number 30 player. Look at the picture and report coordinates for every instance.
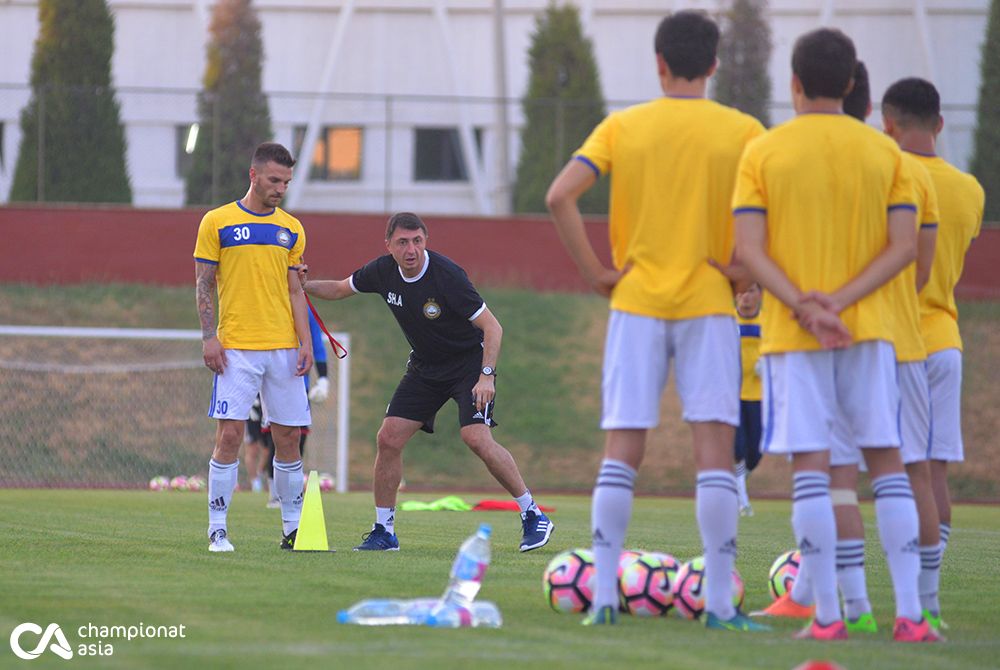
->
[0,325,350,492]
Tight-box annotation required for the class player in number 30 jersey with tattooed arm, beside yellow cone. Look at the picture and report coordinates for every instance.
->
[194,142,313,551]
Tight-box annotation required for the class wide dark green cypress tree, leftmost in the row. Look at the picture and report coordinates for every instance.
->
[10,0,132,202]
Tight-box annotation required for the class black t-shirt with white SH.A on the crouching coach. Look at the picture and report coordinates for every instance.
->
[351,250,486,369]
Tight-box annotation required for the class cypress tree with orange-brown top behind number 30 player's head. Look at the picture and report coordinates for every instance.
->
[186,0,272,205]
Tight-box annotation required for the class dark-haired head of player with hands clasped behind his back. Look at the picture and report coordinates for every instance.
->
[792,28,858,100]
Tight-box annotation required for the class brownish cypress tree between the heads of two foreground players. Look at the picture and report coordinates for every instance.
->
[715,0,771,126]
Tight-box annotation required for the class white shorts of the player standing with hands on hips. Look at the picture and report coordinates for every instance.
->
[601,310,743,430]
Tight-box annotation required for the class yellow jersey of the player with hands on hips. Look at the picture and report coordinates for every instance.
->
[574,97,764,319]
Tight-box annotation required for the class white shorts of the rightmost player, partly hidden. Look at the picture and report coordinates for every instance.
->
[927,349,965,462]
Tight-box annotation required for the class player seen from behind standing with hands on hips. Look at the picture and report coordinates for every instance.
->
[547,11,766,630]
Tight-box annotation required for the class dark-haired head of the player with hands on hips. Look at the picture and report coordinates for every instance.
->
[654,9,719,81]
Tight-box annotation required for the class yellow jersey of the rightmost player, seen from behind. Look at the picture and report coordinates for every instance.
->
[914,154,986,355]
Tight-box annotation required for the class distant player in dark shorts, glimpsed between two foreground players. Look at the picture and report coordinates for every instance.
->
[733,282,761,516]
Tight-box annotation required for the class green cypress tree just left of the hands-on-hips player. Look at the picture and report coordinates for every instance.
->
[514,3,608,214]
